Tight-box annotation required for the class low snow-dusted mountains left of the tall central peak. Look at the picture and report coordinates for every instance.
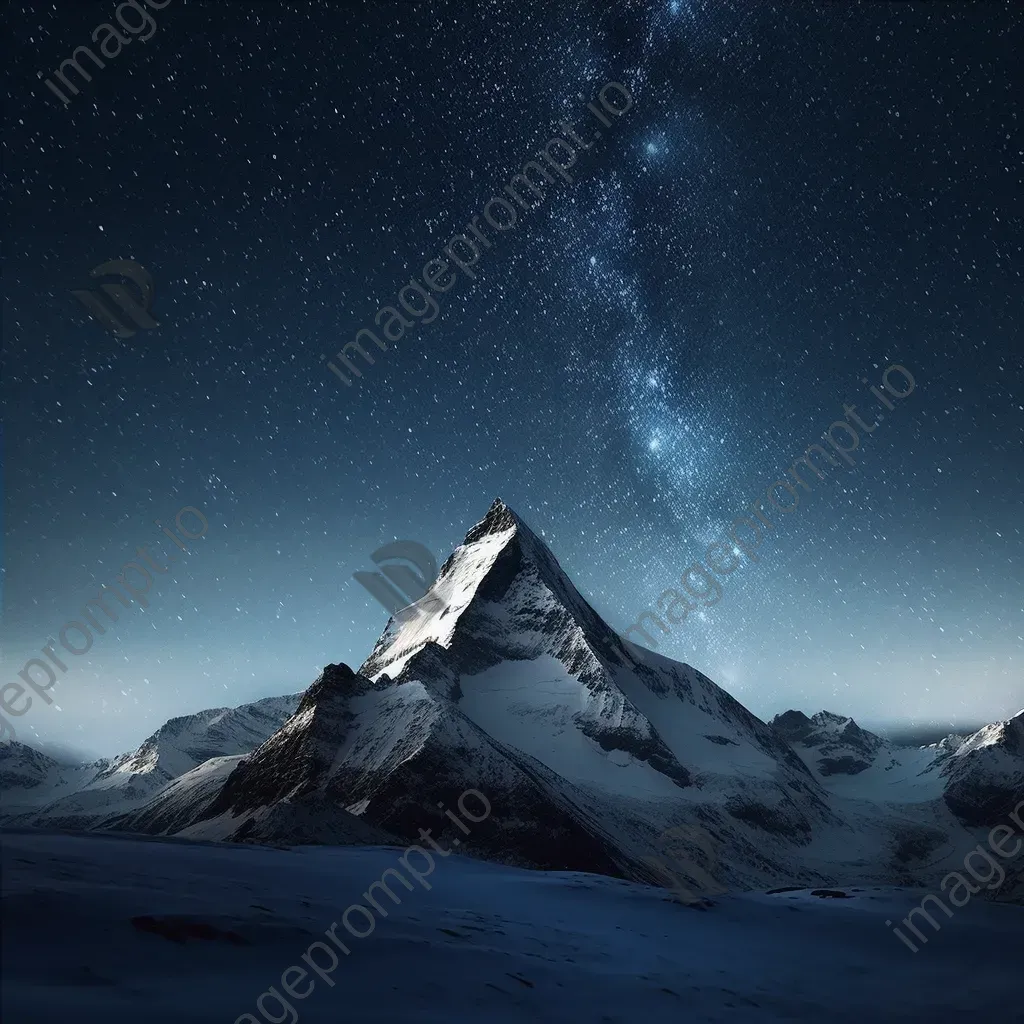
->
[0,693,301,828]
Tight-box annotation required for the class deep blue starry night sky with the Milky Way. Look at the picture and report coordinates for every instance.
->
[0,0,1024,755]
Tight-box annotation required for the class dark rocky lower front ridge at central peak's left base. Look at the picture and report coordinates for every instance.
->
[181,651,650,878]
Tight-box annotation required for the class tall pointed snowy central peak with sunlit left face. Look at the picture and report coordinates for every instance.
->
[172,502,860,884]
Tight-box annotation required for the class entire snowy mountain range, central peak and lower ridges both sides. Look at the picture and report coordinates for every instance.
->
[0,501,1024,898]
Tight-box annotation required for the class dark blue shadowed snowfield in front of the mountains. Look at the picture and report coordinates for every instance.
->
[2,833,1024,1024]
